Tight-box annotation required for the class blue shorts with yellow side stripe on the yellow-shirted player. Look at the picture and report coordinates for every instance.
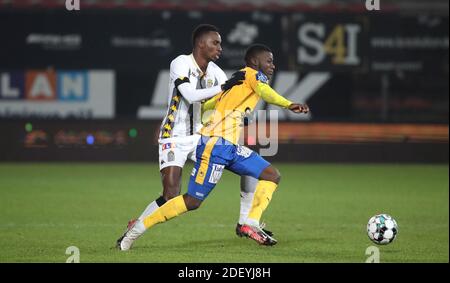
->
[187,136,270,200]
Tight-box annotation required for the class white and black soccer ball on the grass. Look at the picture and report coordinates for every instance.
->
[367,214,398,245]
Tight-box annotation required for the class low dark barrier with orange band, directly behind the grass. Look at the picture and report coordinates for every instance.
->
[0,119,449,163]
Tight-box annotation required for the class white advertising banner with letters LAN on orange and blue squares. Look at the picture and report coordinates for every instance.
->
[0,69,115,119]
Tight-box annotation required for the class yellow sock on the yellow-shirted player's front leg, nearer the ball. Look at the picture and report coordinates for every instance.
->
[248,180,277,225]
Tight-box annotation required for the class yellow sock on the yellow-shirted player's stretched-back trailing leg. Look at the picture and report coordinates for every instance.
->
[143,196,187,229]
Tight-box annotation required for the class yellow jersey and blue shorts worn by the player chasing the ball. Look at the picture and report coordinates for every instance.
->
[187,67,292,200]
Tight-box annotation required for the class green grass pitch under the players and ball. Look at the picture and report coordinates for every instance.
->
[0,163,449,263]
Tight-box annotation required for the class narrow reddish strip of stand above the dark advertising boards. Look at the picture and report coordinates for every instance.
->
[0,0,448,13]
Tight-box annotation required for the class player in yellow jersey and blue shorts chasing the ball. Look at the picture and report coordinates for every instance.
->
[121,44,309,245]
